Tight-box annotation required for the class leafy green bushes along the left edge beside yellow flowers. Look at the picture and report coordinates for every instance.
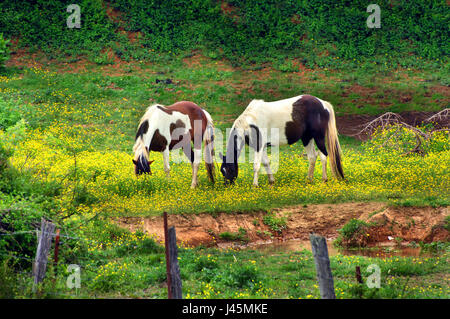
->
[0,100,56,266]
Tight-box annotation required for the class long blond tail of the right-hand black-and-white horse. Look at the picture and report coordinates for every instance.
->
[324,101,345,179]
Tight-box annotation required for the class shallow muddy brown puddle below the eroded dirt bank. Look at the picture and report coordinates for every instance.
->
[218,239,439,258]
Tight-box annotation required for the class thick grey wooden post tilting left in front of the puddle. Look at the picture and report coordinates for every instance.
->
[309,234,336,299]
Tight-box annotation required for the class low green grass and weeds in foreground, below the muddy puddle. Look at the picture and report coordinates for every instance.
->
[0,229,450,299]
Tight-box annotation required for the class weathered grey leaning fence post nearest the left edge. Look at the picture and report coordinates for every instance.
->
[33,218,55,292]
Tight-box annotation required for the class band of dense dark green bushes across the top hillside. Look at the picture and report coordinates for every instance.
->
[0,0,449,65]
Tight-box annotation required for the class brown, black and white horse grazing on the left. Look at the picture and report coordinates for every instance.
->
[133,101,214,188]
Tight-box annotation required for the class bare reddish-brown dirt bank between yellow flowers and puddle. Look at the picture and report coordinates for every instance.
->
[117,203,450,246]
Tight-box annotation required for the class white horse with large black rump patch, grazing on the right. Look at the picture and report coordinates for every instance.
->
[220,95,344,186]
